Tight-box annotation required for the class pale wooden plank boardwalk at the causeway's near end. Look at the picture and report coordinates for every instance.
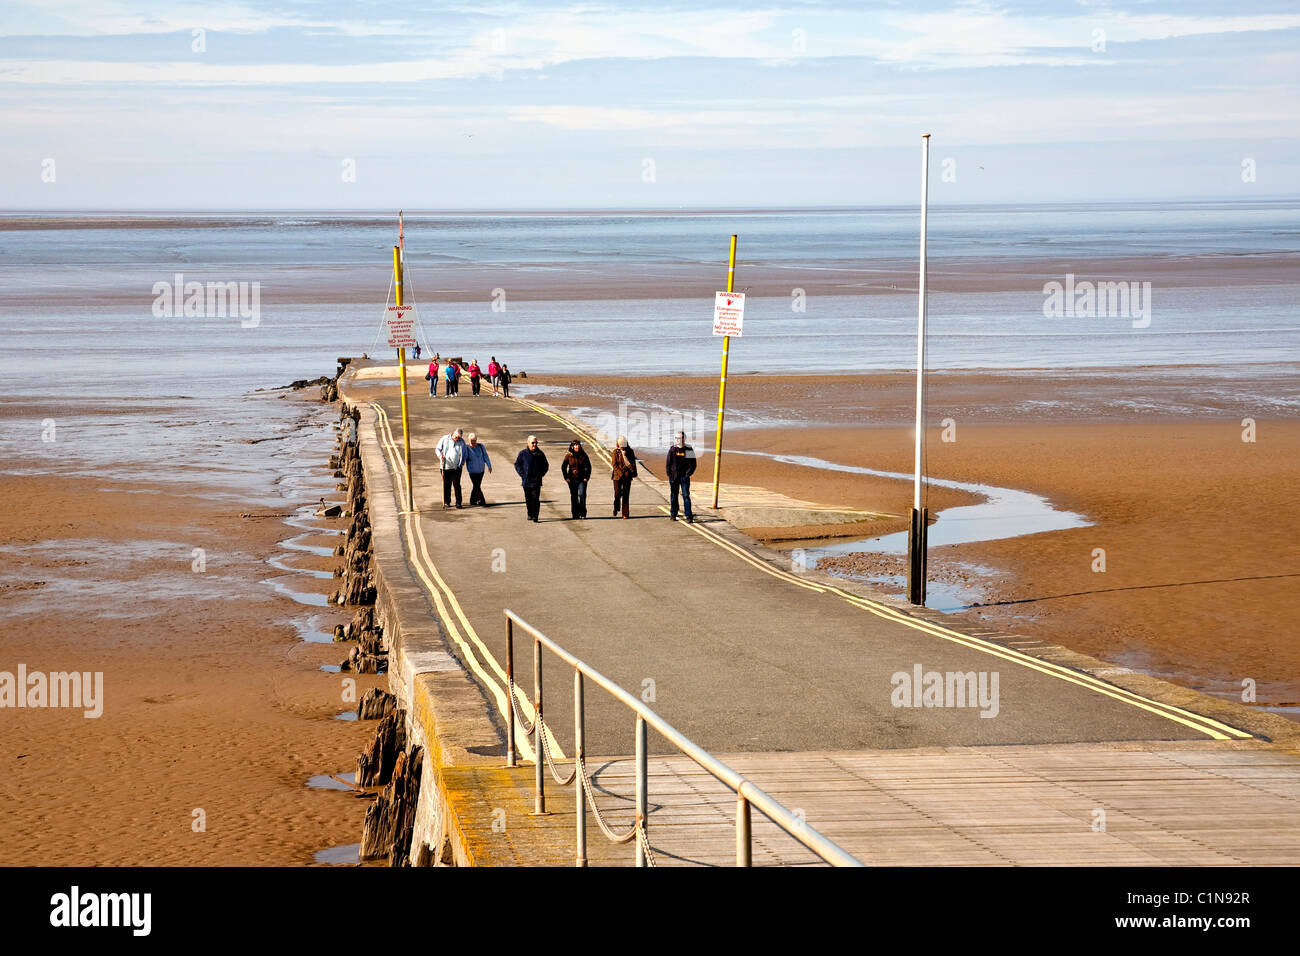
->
[572,744,1300,866]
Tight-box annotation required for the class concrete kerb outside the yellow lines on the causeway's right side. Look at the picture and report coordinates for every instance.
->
[519,399,1300,753]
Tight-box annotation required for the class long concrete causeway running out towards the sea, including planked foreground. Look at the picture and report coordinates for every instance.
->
[339,362,1300,865]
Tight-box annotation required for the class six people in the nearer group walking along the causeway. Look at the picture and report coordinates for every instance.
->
[437,428,696,524]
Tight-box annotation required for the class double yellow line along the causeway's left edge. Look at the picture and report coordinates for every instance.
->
[371,402,564,760]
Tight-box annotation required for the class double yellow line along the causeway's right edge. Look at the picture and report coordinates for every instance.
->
[516,399,1253,740]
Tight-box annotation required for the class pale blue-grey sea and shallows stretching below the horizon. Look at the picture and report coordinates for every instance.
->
[0,200,1300,397]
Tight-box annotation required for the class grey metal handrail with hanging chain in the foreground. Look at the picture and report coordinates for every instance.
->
[504,607,865,866]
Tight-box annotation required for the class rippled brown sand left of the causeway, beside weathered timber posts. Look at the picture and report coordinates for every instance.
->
[0,446,386,865]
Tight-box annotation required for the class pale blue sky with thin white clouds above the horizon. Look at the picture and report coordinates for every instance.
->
[0,0,1300,209]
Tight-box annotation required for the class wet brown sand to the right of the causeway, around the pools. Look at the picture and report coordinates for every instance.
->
[532,368,1300,715]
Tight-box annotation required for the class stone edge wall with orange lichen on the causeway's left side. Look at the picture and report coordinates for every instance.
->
[339,360,572,866]
